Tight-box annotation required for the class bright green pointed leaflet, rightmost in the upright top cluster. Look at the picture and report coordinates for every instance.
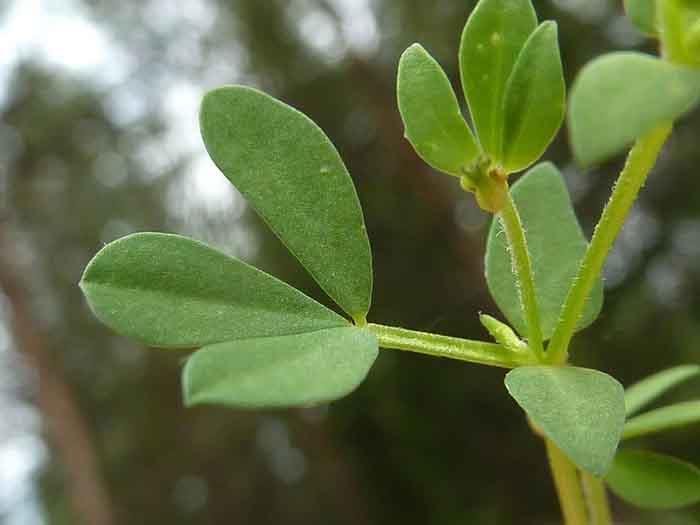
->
[503,22,566,172]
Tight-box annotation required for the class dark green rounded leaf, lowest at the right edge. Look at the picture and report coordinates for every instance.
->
[605,450,700,509]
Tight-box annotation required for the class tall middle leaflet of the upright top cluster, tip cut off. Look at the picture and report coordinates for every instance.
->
[459,0,537,161]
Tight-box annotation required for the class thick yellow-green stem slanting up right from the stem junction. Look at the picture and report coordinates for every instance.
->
[547,124,671,363]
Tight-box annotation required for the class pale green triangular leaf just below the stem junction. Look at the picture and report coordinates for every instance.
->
[505,366,625,476]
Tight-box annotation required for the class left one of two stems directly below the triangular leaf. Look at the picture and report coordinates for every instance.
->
[544,438,589,525]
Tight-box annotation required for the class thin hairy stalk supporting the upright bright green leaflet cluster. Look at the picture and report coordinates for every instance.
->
[499,192,544,359]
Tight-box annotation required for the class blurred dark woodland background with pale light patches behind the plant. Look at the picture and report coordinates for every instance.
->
[0,0,700,525]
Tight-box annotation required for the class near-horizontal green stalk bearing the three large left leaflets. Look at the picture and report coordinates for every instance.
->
[367,323,536,368]
